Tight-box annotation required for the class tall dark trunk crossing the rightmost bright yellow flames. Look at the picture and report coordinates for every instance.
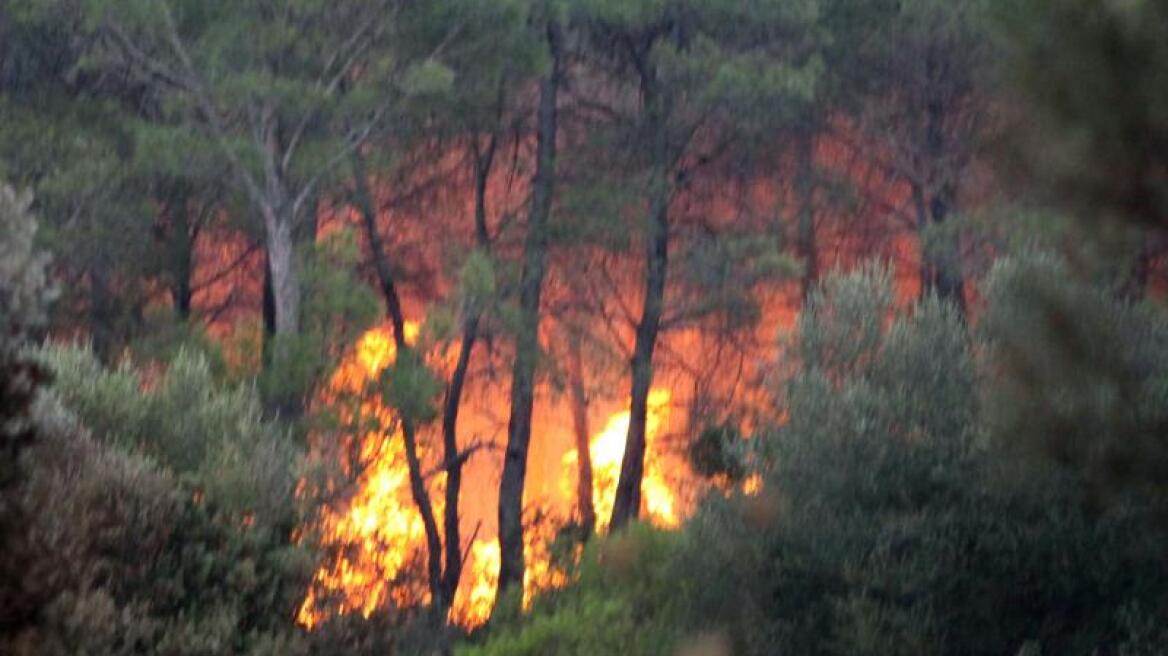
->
[609,65,670,531]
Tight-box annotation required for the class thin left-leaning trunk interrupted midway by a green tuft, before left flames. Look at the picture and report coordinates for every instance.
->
[352,155,446,617]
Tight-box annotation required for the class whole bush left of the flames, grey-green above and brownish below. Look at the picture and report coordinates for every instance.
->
[0,347,313,656]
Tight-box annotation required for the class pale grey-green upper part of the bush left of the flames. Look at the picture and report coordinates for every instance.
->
[42,347,299,526]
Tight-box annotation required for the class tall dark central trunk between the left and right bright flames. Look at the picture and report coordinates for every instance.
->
[495,21,562,608]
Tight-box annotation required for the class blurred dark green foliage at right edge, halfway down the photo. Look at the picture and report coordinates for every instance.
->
[980,253,1168,511]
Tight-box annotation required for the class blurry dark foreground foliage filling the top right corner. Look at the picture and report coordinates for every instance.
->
[994,0,1168,226]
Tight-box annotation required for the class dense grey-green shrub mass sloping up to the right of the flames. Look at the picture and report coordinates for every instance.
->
[466,261,1168,656]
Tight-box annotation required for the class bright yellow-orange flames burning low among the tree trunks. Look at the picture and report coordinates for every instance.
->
[298,323,681,629]
